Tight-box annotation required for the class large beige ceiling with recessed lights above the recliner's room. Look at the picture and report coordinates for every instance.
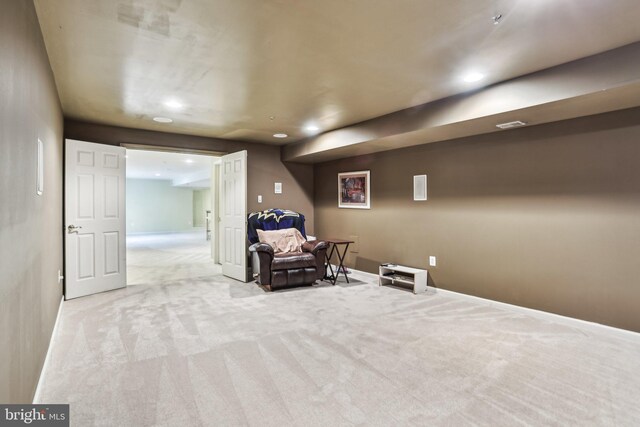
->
[35,0,640,144]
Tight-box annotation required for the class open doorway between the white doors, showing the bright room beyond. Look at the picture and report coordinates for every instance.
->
[126,149,221,285]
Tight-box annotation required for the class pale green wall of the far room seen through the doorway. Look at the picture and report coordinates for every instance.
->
[127,178,194,234]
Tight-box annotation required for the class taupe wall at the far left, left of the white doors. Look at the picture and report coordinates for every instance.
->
[0,0,63,403]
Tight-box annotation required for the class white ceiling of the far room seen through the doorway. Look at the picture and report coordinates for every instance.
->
[127,149,216,188]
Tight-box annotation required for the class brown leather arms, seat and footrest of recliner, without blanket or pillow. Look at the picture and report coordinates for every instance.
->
[249,241,328,291]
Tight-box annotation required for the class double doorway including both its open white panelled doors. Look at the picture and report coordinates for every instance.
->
[64,139,250,299]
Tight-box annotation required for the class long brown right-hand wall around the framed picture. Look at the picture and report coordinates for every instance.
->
[315,109,640,331]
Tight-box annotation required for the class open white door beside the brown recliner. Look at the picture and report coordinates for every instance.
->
[220,151,247,282]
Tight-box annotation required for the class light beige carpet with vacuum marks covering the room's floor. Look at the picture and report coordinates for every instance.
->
[41,234,640,426]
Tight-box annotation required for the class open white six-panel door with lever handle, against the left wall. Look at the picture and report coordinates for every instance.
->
[65,139,127,299]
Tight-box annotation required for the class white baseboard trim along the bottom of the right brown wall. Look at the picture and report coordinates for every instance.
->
[352,269,640,342]
